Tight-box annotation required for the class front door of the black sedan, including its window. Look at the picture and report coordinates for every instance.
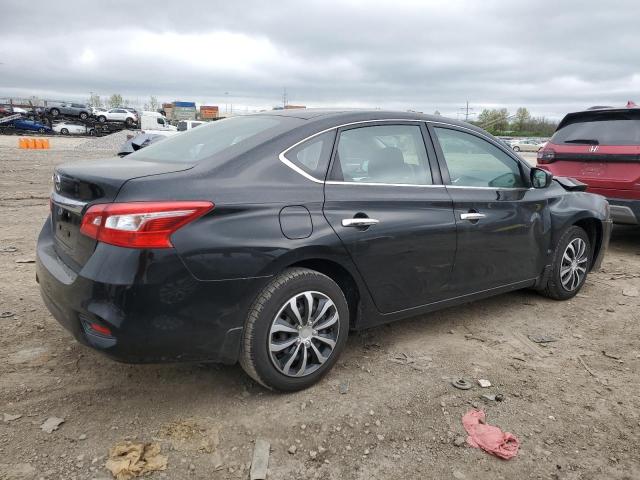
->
[429,124,549,295]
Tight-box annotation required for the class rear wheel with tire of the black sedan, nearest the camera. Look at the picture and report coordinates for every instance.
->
[240,268,349,392]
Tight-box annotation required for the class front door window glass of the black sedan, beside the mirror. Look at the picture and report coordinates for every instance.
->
[434,127,527,188]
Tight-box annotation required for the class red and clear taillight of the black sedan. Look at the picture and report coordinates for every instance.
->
[80,201,213,248]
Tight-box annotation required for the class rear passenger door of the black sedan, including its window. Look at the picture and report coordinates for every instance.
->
[324,122,456,313]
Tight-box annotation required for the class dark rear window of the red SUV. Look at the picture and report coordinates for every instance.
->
[551,111,640,145]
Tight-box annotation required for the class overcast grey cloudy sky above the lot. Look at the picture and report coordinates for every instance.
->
[0,0,640,118]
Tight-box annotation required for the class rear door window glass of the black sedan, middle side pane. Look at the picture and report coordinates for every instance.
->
[332,125,432,185]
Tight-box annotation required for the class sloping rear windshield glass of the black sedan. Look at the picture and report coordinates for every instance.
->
[127,115,283,163]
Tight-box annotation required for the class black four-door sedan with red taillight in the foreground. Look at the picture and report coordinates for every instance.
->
[37,110,611,390]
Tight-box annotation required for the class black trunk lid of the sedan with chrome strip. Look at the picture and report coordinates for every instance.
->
[51,158,193,271]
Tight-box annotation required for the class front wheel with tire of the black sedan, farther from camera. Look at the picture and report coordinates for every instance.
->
[540,225,591,300]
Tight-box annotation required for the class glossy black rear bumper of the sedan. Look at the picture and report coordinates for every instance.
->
[36,221,265,363]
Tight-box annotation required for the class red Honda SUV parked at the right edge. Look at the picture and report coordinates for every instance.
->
[538,102,640,225]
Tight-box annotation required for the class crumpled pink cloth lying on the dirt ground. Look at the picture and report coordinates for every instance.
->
[462,410,520,460]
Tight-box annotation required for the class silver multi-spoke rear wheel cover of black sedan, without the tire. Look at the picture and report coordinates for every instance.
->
[269,291,340,377]
